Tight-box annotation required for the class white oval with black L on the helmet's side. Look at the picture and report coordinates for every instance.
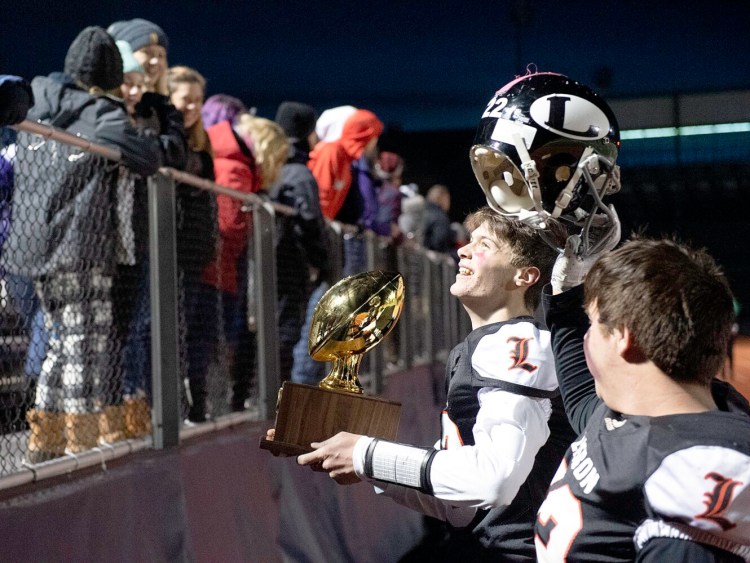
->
[529,94,610,141]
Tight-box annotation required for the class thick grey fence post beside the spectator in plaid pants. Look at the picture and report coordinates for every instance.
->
[148,174,180,449]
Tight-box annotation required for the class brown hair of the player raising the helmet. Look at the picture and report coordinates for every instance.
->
[584,236,734,385]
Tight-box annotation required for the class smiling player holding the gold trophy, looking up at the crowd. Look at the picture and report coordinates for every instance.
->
[298,207,572,561]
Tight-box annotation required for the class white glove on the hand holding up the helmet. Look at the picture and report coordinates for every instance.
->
[551,205,620,294]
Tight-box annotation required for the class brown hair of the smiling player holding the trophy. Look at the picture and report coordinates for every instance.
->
[464,206,565,311]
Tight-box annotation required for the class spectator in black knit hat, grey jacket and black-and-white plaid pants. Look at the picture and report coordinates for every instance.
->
[3,26,184,463]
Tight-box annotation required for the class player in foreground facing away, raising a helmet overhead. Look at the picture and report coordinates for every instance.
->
[535,229,750,562]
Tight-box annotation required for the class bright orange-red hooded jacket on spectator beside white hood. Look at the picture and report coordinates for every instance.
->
[307,109,383,219]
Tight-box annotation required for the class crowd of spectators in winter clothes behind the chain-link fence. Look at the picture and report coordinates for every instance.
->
[0,18,461,463]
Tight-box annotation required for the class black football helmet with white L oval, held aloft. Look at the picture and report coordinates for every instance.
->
[470,72,620,254]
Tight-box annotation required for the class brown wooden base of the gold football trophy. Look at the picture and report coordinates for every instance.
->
[260,381,401,456]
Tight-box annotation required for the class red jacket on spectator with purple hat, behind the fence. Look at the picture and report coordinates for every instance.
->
[203,121,261,295]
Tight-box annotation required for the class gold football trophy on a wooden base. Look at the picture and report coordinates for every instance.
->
[260,271,404,455]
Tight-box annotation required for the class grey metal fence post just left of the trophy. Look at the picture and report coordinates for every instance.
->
[248,204,281,420]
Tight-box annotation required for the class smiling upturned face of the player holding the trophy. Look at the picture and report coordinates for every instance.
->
[450,223,520,316]
